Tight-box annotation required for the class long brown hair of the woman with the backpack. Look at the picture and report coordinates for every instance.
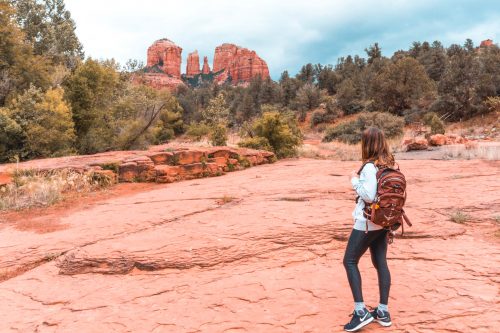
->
[361,127,394,167]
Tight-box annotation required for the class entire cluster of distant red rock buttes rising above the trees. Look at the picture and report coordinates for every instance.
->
[137,38,269,90]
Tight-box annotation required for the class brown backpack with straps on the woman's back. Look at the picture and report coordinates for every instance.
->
[358,162,412,234]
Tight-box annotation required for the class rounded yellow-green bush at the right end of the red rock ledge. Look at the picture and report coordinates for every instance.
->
[240,112,302,158]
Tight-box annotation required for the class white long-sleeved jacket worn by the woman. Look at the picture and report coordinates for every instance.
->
[351,163,383,231]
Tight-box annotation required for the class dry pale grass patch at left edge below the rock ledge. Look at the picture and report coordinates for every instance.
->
[0,169,113,210]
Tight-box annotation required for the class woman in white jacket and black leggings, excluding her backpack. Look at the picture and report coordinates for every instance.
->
[344,127,394,332]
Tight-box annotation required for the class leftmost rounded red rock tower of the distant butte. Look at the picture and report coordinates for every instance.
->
[147,38,182,78]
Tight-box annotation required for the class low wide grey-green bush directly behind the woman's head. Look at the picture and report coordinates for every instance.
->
[323,112,404,144]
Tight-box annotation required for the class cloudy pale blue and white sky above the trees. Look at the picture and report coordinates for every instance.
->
[65,0,500,79]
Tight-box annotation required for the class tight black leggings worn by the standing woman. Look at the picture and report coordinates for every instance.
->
[344,229,391,304]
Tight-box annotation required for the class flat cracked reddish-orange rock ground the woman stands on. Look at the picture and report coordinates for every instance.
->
[0,159,500,333]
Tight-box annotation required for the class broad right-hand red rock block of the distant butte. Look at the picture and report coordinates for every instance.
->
[213,44,269,83]
